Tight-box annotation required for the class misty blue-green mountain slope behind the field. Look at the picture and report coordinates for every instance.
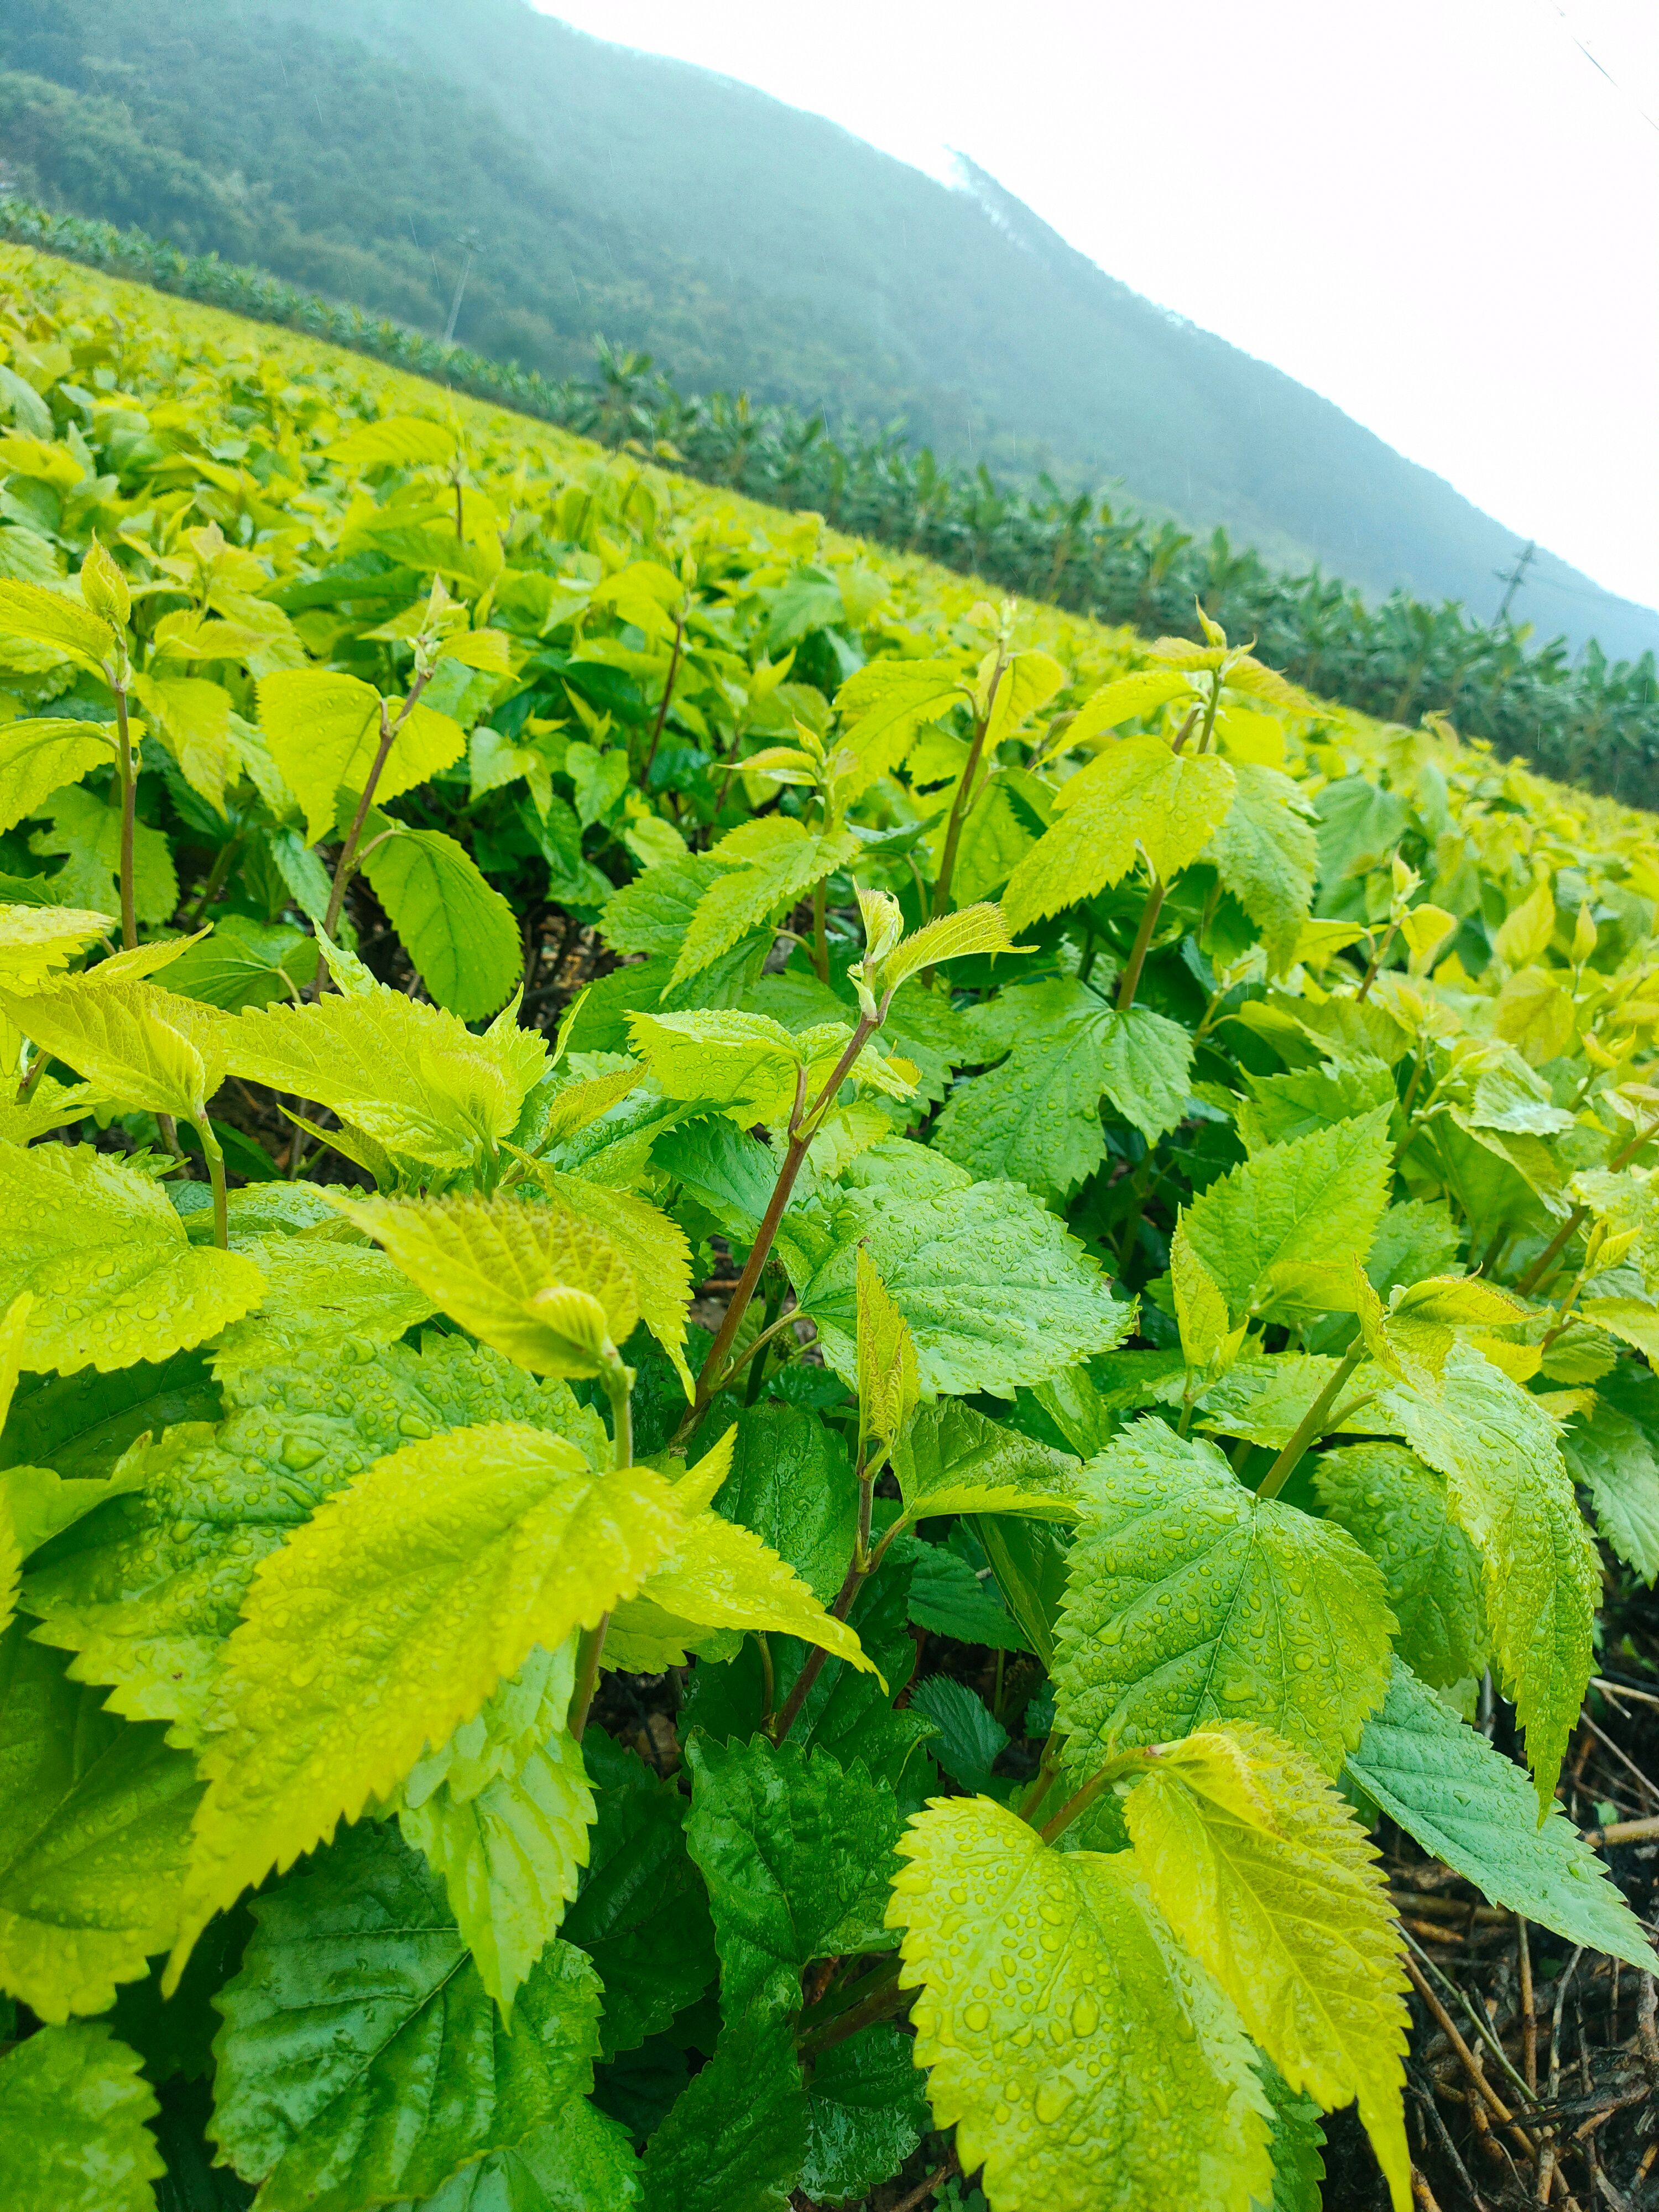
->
[0,0,1659,653]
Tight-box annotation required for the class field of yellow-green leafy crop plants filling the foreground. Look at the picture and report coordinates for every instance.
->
[0,248,1659,2212]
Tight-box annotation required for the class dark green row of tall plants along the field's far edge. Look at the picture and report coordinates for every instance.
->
[0,199,1659,805]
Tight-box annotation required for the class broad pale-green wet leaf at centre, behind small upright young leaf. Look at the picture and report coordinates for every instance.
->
[796,1183,1133,1398]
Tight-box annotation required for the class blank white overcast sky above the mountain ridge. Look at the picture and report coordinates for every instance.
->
[533,0,1659,606]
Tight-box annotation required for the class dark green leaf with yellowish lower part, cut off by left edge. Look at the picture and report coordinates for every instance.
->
[0,1621,201,2022]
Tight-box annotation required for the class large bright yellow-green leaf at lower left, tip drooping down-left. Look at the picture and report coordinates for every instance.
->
[168,1422,686,1978]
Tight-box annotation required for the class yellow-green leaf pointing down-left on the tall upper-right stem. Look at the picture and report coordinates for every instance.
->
[1002,737,1234,931]
